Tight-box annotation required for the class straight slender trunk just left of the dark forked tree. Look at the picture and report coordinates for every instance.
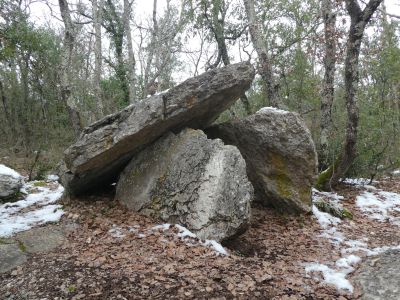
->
[318,0,337,169]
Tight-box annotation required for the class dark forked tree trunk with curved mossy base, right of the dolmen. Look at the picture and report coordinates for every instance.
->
[318,0,383,190]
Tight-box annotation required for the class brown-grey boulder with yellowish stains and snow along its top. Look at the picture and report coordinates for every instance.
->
[206,108,317,213]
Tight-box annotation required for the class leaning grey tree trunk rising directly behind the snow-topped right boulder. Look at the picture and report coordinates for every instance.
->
[243,0,283,108]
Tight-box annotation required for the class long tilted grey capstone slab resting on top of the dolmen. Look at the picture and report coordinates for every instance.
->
[60,63,254,194]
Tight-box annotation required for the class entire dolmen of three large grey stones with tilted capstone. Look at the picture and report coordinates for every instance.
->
[59,62,317,241]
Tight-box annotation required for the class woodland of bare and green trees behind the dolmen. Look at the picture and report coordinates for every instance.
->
[0,0,400,185]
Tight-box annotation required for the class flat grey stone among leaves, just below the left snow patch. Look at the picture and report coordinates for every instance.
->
[16,226,65,254]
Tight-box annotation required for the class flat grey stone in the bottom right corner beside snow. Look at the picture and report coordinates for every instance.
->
[353,250,400,300]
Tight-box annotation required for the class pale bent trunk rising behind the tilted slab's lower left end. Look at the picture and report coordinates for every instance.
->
[58,0,82,136]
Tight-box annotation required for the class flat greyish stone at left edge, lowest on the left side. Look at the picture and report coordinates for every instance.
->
[0,240,27,273]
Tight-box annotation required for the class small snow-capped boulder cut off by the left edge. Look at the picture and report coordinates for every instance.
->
[0,164,23,200]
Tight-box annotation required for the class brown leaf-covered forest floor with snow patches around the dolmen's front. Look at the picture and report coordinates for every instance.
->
[0,175,400,299]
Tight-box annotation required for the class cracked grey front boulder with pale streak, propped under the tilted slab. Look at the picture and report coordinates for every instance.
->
[116,129,253,241]
